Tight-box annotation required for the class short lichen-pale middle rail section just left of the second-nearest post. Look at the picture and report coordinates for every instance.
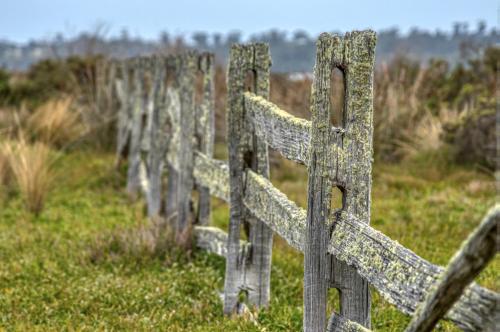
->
[193,151,229,202]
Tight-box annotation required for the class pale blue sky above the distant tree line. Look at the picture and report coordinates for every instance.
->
[0,0,500,43]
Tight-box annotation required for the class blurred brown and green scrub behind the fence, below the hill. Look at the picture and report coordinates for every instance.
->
[0,43,500,169]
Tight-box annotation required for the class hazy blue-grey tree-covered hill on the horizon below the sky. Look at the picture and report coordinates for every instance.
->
[0,22,500,72]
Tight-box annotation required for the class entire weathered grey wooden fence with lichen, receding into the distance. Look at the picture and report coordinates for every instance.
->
[107,31,500,331]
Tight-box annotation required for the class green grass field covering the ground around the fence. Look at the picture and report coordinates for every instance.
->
[0,151,500,331]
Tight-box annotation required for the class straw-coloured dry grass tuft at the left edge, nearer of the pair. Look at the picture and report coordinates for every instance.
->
[0,139,54,215]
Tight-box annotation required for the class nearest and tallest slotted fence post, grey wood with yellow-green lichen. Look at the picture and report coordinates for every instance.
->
[304,31,375,331]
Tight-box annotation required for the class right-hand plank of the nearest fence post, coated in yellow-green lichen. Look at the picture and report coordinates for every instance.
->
[332,31,376,328]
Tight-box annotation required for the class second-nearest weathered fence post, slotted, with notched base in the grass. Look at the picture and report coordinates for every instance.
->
[224,43,272,314]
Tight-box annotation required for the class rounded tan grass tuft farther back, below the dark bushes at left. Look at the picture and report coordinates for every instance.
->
[26,97,84,147]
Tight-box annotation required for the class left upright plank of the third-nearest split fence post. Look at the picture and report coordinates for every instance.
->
[175,52,197,245]
